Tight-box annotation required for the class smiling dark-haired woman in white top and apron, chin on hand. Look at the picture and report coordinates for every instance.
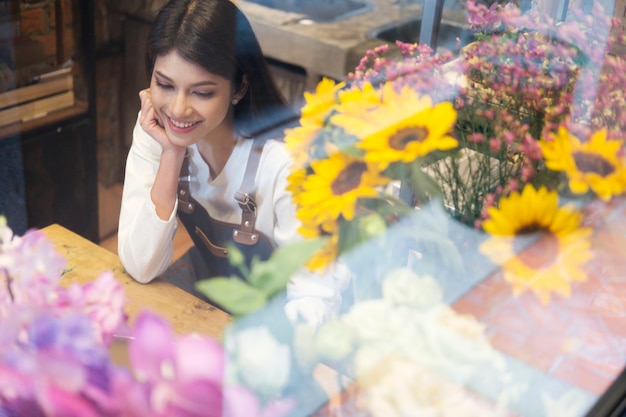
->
[118,0,343,325]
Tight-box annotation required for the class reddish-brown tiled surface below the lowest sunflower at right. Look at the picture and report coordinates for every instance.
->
[454,198,626,395]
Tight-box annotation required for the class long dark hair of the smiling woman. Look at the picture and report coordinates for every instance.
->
[146,0,295,136]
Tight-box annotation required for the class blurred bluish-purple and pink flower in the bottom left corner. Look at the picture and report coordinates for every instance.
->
[0,311,124,417]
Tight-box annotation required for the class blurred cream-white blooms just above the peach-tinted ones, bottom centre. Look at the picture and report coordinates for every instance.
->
[340,269,508,379]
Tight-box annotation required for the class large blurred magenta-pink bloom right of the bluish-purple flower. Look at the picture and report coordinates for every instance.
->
[127,312,294,417]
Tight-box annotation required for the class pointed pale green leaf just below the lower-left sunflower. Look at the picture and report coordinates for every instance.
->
[248,238,327,298]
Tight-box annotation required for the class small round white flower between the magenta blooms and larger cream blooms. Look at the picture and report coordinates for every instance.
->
[230,327,291,396]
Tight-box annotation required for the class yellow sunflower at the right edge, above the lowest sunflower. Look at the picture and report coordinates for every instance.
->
[539,127,626,201]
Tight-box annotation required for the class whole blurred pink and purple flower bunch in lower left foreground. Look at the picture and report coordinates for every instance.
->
[0,217,294,417]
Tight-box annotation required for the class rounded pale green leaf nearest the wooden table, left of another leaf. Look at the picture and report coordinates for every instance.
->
[196,277,267,316]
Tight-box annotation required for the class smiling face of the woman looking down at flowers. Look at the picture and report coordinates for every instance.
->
[150,51,232,146]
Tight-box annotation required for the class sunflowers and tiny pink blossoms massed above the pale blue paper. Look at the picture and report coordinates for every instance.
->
[285,1,626,274]
